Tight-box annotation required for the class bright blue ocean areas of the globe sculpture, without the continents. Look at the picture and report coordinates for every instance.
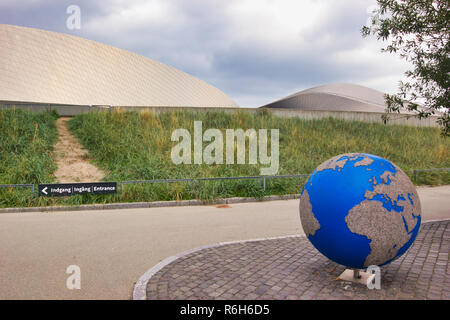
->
[302,154,421,269]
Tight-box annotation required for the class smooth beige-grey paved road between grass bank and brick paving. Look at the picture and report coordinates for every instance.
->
[0,186,450,299]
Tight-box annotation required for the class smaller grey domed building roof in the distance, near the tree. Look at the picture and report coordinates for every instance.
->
[263,83,394,112]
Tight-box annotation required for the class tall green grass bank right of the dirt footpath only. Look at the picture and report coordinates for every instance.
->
[70,110,450,205]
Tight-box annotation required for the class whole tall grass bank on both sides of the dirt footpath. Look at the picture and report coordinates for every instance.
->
[0,110,450,207]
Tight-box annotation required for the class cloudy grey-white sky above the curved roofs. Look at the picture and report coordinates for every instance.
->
[0,0,408,107]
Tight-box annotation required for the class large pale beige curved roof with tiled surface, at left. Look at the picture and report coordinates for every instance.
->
[0,24,237,107]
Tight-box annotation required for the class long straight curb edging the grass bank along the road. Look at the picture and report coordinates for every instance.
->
[0,194,300,213]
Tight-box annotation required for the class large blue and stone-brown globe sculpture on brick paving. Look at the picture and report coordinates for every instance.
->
[300,153,421,269]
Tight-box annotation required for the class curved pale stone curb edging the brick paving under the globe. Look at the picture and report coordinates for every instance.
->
[132,234,306,300]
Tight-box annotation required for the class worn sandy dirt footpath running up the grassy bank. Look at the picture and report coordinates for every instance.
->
[54,118,105,183]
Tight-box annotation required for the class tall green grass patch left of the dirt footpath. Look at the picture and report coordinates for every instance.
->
[0,109,58,206]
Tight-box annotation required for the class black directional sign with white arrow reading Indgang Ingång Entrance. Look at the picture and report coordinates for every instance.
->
[38,182,117,197]
